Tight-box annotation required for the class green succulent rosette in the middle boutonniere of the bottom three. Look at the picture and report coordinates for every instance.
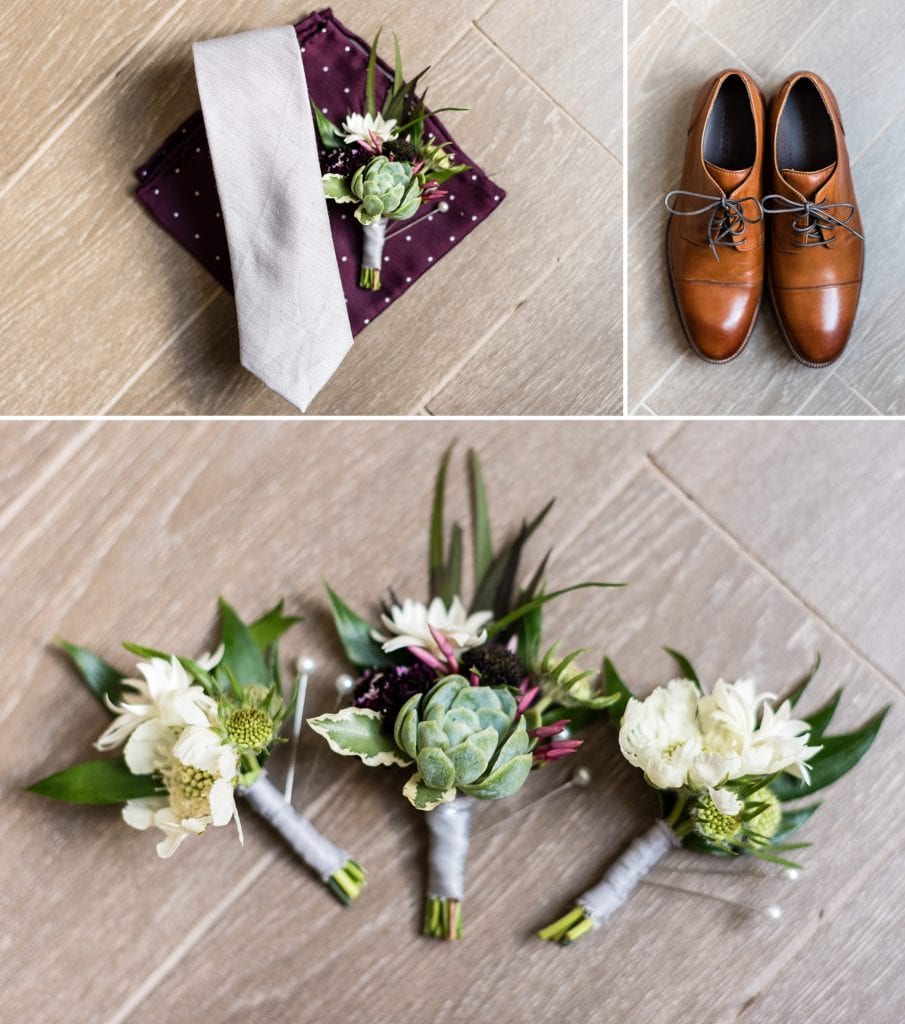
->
[394,676,533,810]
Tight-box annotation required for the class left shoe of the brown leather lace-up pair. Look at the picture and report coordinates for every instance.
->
[666,70,766,362]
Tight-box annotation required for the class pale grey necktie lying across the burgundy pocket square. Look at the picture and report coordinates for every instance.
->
[193,26,352,410]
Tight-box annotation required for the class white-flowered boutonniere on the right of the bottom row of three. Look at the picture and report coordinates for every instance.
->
[540,650,889,945]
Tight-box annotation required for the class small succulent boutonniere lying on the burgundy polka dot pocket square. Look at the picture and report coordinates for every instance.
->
[314,32,468,292]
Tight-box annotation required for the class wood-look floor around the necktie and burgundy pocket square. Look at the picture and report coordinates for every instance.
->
[0,0,622,415]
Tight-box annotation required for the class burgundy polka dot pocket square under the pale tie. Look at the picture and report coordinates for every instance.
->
[136,9,506,335]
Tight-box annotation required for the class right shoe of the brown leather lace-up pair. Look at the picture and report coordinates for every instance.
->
[764,72,864,367]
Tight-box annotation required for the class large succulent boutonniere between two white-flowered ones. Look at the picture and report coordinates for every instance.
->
[308,451,620,939]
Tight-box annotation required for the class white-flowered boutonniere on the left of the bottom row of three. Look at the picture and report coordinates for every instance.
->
[30,601,364,903]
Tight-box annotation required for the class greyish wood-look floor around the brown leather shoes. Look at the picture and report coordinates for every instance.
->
[629,0,905,416]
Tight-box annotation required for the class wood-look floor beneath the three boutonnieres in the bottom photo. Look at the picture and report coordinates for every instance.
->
[0,420,905,1024]
